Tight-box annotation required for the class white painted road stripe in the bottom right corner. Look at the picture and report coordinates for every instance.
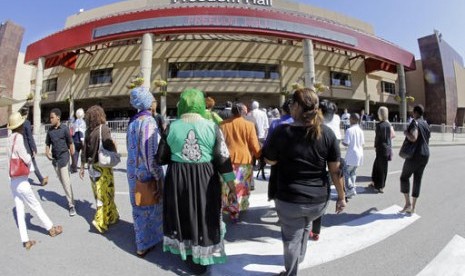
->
[417,235,465,276]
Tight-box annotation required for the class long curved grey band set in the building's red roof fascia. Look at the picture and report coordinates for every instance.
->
[94,15,358,46]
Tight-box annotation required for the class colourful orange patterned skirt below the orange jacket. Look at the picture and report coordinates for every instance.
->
[222,164,253,221]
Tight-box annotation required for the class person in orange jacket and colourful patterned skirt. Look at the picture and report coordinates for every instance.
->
[220,103,260,222]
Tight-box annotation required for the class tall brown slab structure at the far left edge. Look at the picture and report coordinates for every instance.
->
[0,21,24,126]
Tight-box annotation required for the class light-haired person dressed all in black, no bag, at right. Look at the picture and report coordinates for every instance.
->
[368,106,393,193]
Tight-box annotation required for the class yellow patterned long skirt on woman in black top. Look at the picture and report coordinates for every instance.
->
[91,164,119,233]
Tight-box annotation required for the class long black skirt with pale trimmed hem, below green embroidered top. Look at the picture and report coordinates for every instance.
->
[163,163,226,265]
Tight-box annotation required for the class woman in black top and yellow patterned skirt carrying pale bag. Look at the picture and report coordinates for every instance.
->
[79,105,119,234]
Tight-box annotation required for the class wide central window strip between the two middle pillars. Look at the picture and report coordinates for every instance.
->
[168,62,280,80]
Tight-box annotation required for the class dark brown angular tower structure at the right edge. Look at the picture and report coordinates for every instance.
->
[406,32,465,126]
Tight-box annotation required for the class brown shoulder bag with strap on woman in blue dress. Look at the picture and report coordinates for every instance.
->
[134,122,161,207]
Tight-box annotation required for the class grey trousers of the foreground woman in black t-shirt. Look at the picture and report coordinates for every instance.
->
[275,199,328,276]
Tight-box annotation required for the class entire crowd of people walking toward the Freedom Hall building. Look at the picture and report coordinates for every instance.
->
[8,87,430,275]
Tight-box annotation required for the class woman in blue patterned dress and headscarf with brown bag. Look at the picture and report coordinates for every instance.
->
[127,87,163,257]
